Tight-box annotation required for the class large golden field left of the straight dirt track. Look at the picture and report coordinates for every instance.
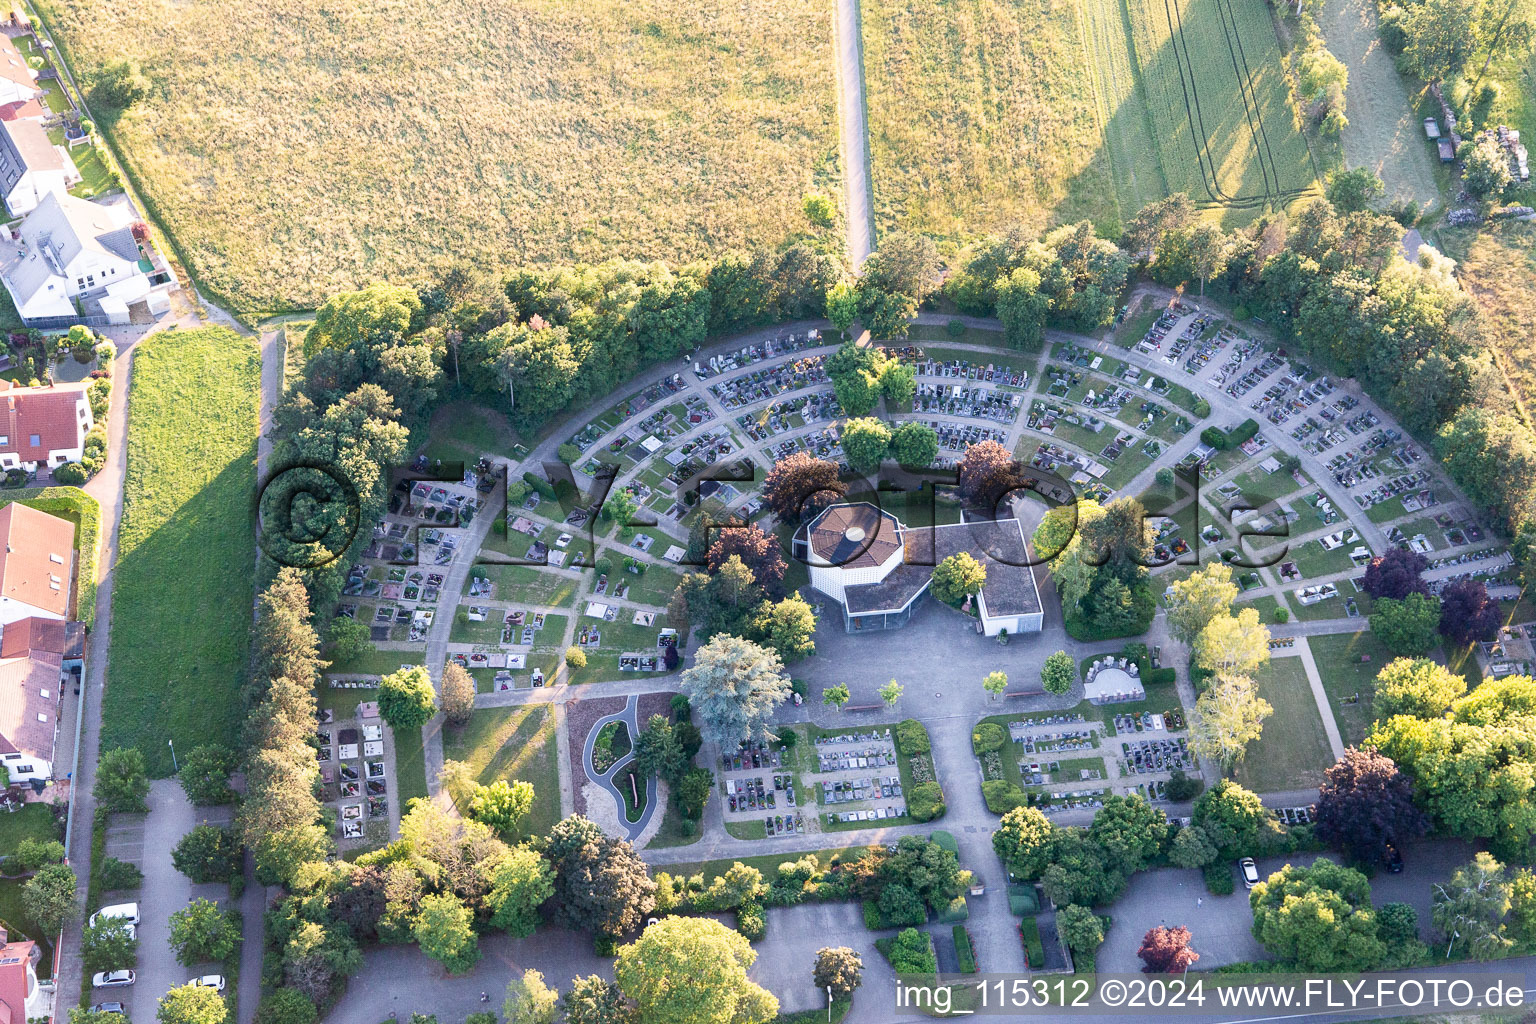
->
[38,0,842,313]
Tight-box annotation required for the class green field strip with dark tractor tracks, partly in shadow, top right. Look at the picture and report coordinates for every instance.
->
[1124,0,1318,207]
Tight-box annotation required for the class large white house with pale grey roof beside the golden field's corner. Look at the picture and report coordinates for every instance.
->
[0,192,158,327]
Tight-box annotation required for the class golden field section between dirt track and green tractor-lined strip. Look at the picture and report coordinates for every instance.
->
[860,0,1135,236]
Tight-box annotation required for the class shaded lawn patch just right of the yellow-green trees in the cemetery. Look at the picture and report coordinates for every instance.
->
[1236,657,1333,792]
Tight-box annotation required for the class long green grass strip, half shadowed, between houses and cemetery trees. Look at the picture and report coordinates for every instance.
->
[101,327,261,777]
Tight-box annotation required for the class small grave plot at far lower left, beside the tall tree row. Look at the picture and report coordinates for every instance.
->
[315,702,393,841]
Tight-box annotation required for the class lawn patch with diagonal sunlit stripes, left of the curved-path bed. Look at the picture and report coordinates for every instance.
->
[442,705,561,835]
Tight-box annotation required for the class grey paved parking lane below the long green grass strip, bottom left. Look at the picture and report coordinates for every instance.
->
[101,778,230,1021]
